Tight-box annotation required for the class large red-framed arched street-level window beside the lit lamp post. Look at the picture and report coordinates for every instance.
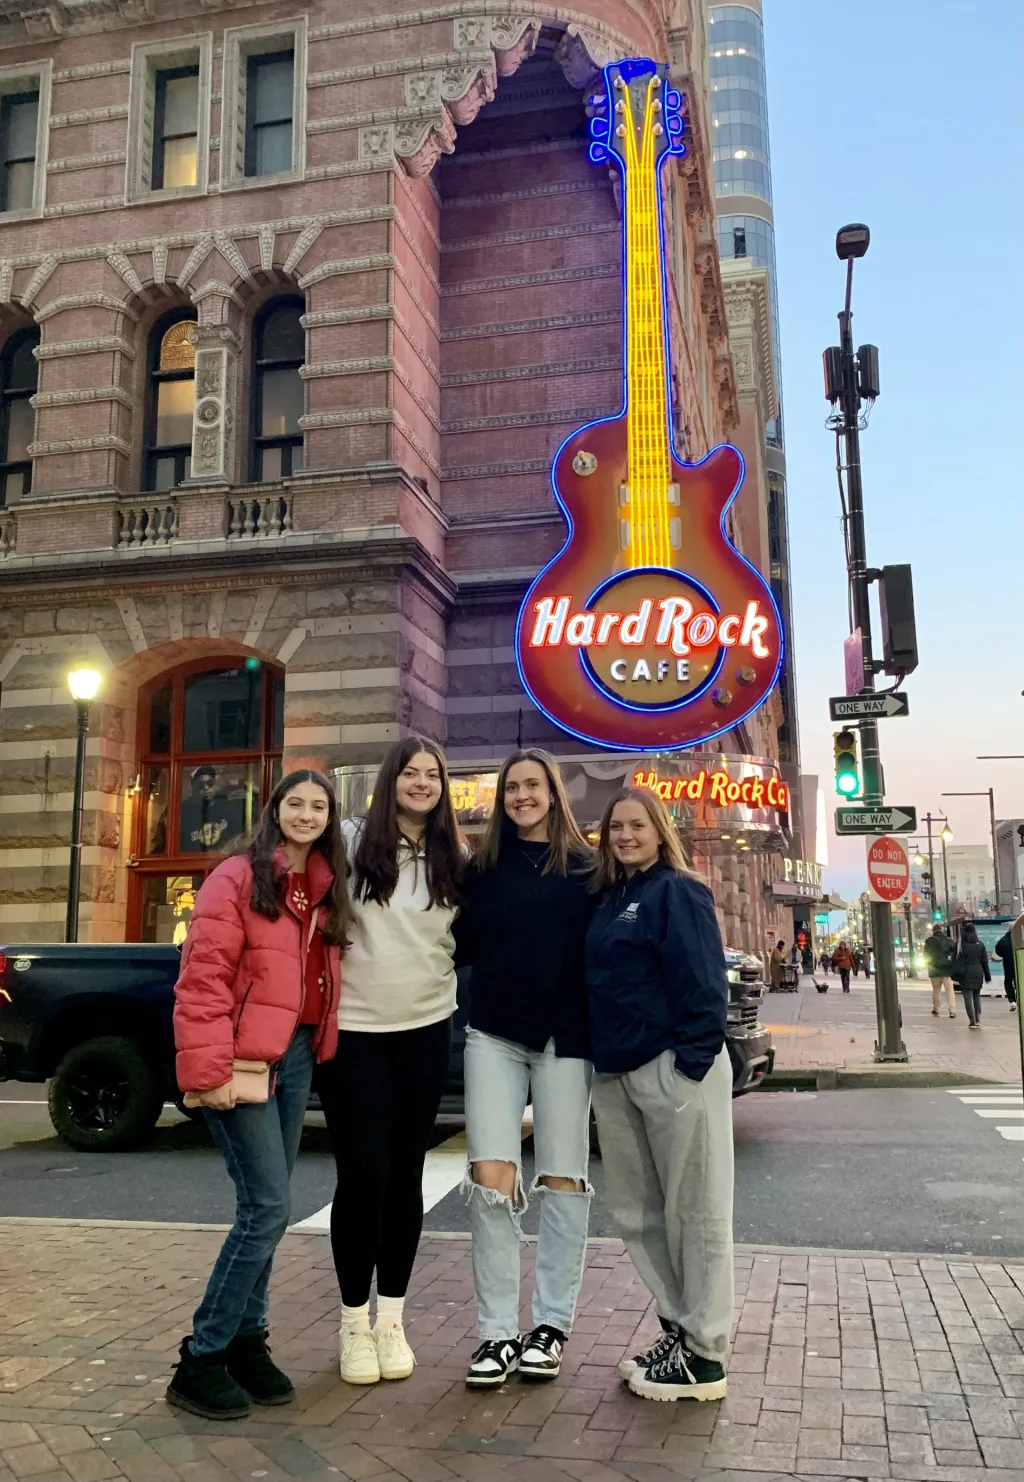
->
[129,658,285,941]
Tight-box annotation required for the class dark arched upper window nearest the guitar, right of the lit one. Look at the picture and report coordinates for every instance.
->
[252,298,305,483]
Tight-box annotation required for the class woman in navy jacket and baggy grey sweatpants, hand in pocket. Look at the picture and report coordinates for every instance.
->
[587,788,734,1399]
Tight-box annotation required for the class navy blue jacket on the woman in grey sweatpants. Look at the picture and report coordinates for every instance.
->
[587,861,729,1080]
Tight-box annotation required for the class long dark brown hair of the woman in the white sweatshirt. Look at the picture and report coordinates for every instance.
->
[353,737,464,910]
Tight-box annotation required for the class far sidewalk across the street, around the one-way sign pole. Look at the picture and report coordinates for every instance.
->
[762,974,1024,1084]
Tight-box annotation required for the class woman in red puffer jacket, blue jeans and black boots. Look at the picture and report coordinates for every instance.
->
[167,771,350,1420]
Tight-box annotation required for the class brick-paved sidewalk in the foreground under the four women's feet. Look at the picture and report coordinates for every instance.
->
[0,1221,1024,1482]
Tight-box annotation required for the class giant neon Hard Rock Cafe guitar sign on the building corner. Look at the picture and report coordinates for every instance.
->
[516,59,782,751]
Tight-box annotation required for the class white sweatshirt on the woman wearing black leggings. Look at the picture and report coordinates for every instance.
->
[338,818,455,1034]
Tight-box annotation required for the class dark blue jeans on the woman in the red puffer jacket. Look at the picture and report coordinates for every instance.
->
[190,1024,313,1353]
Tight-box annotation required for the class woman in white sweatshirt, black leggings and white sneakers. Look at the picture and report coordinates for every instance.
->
[317,737,464,1384]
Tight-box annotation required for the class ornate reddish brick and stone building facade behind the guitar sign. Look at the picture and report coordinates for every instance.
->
[0,0,794,941]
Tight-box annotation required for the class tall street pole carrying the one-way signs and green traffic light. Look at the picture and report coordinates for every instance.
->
[839,233,908,1061]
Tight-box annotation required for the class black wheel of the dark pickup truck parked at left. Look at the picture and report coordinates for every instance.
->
[49,1034,163,1153]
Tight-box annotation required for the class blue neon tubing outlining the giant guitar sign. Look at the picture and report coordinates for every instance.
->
[516,56,785,756]
